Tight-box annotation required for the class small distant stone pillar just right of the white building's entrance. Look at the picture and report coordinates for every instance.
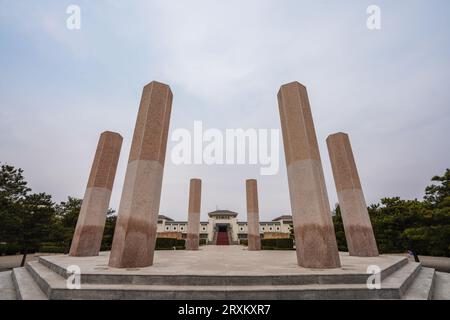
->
[245,180,261,251]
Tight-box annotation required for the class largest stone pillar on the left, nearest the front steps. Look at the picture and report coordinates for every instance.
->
[109,82,172,268]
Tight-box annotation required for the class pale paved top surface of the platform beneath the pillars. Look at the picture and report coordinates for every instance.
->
[45,246,404,276]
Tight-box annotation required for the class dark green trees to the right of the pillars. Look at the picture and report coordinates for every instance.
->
[333,169,450,257]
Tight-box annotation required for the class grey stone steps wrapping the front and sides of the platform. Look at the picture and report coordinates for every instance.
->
[0,252,450,300]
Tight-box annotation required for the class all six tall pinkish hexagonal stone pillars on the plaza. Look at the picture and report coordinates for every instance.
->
[70,82,378,268]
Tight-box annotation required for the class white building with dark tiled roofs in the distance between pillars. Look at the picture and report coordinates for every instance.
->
[157,210,292,244]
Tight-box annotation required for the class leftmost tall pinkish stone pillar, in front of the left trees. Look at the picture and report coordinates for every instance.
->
[69,131,123,257]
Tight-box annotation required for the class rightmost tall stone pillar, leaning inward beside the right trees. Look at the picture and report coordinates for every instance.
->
[327,133,378,257]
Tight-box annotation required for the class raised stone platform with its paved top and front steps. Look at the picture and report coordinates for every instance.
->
[7,246,435,300]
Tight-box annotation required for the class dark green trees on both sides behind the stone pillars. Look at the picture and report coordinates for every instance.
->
[0,164,450,264]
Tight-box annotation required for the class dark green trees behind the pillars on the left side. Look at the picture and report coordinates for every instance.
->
[0,164,116,266]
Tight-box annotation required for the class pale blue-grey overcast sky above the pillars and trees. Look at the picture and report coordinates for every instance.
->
[0,0,450,220]
